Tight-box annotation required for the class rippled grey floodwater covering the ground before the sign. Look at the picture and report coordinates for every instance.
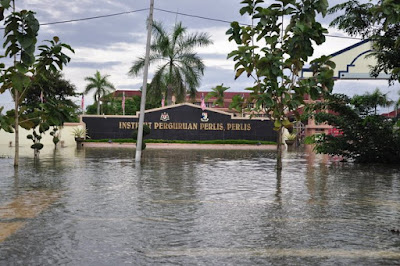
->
[0,148,400,265]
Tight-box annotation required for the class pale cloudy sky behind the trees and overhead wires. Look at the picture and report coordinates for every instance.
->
[0,0,400,113]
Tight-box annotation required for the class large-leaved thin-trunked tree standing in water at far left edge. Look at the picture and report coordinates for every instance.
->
[0,0,73,167]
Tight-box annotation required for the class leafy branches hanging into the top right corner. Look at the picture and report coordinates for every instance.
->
[329,0,400,82]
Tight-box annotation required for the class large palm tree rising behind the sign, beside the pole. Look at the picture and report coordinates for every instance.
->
[129,22,212,105]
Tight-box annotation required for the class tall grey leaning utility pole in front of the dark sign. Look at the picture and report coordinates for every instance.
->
[135,0,154,162]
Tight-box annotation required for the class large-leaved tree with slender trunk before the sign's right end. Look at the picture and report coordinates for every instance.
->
[227,0,334,170]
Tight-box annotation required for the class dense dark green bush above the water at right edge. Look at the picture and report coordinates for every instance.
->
[308,94,400,164]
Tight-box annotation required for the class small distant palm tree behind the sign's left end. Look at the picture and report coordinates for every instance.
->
[84,70,115,115]
